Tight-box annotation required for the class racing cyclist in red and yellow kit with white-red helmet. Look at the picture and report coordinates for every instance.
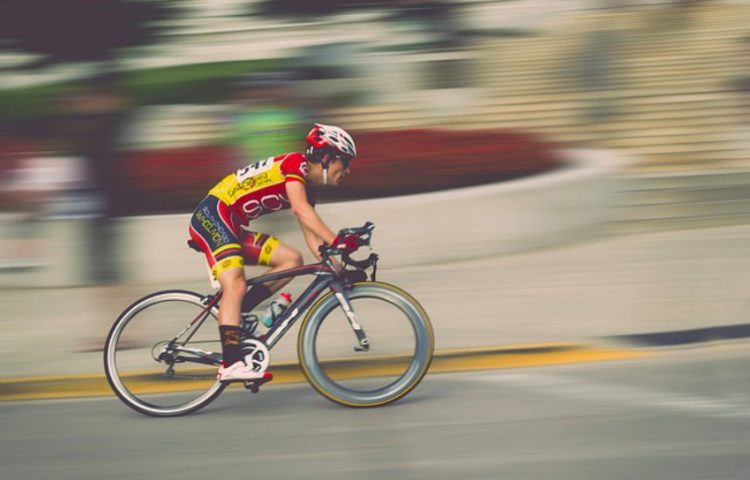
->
[189,124,357,382]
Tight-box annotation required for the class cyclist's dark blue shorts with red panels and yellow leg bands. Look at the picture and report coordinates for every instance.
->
[190,195,279,280]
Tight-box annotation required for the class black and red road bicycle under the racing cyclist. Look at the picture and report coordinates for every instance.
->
[104,222,434,417]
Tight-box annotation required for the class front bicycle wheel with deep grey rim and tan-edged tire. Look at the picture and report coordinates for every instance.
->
[297,282,435,407]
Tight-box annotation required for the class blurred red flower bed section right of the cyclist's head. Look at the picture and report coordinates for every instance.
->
[321,130,560,199]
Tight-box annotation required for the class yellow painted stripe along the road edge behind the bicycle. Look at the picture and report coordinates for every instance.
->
[0,343,653,401]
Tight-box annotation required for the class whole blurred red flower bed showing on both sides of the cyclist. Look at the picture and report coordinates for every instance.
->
[120,130,560,215]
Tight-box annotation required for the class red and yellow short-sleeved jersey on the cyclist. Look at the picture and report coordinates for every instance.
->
[209,153,312,220]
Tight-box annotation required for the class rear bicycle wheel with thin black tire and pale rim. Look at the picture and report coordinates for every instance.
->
[104,290,224,417]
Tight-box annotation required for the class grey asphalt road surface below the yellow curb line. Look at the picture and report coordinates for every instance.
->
[5,344,750,480]
